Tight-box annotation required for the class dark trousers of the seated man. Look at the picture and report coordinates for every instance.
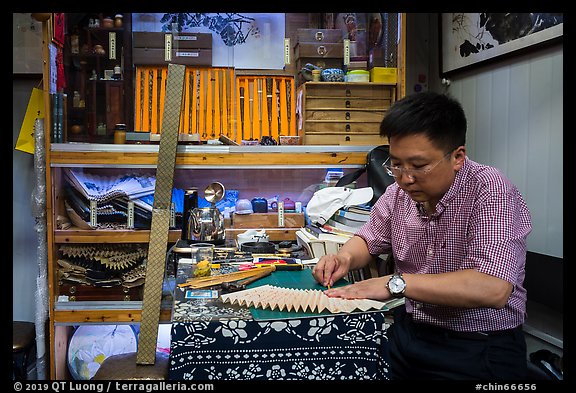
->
[388,307,527,381]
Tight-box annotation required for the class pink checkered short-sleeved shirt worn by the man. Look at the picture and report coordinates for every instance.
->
[356,158,532,331]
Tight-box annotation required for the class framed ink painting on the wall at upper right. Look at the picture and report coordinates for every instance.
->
[440,13,564,75]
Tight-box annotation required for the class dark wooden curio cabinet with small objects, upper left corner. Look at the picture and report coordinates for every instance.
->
[63,14,132,142]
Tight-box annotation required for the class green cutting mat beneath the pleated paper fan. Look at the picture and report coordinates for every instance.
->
[247,269,349,321]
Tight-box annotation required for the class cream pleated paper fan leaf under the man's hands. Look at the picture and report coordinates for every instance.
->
[220,285,385,313]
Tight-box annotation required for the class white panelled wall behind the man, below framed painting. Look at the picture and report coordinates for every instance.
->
[447,45,564,258]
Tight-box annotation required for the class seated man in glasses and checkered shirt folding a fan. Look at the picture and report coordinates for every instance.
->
[313,92,531,380]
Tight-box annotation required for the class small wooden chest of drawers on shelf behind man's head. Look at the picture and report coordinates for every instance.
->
[296,82,396,145]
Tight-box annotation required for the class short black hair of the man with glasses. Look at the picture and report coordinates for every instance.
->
[380,92,466,153]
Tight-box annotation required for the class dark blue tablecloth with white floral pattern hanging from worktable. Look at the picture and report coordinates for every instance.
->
[168,311,389,381]
